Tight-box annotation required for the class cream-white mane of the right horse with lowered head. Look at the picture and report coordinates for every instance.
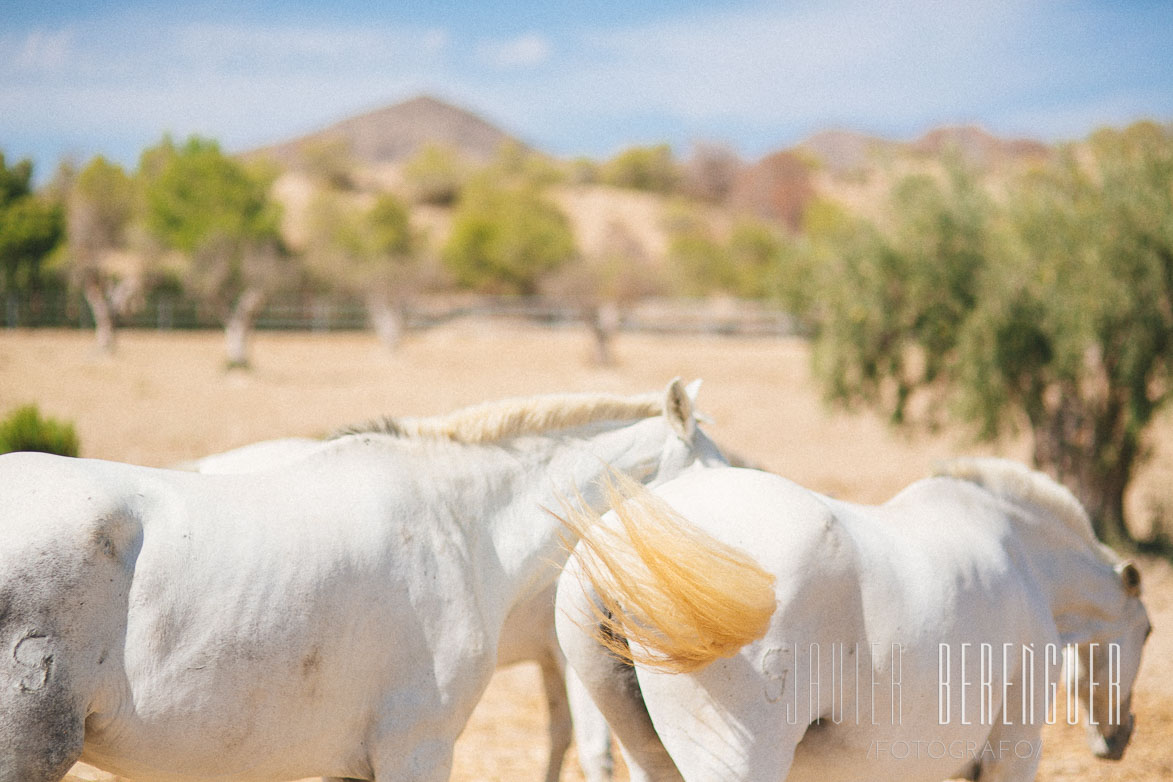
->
[935,457,1101,550]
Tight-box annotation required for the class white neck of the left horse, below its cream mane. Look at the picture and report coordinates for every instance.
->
[491,419,667,605]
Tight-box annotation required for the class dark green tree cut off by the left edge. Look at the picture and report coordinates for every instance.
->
[0,152,65,293]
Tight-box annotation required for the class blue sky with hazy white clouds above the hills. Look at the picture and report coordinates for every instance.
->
[0,0,1173,178]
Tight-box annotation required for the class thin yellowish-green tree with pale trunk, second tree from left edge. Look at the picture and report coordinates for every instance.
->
[65,156,142,353]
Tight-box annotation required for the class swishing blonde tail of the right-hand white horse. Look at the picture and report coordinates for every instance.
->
[561,475,775,673]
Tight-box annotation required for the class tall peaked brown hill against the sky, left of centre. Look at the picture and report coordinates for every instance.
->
[248,95,526,168]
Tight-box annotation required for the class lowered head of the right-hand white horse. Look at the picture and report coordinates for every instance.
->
[1066,562,1152,760]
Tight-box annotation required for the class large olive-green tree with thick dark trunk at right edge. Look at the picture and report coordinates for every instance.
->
[960,123,1173,544]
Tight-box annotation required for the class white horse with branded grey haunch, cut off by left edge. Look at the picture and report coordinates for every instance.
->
[0,382,720,782]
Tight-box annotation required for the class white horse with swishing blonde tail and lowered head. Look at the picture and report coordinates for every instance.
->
[557,460,1151,782]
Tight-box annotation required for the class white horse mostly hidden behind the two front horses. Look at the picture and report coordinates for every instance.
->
[179,438,619,782]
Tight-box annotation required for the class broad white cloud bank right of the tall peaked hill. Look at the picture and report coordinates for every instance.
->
[483,0,1173,154]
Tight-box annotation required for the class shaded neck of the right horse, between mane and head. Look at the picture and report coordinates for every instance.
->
[1018,508,1121,644]
